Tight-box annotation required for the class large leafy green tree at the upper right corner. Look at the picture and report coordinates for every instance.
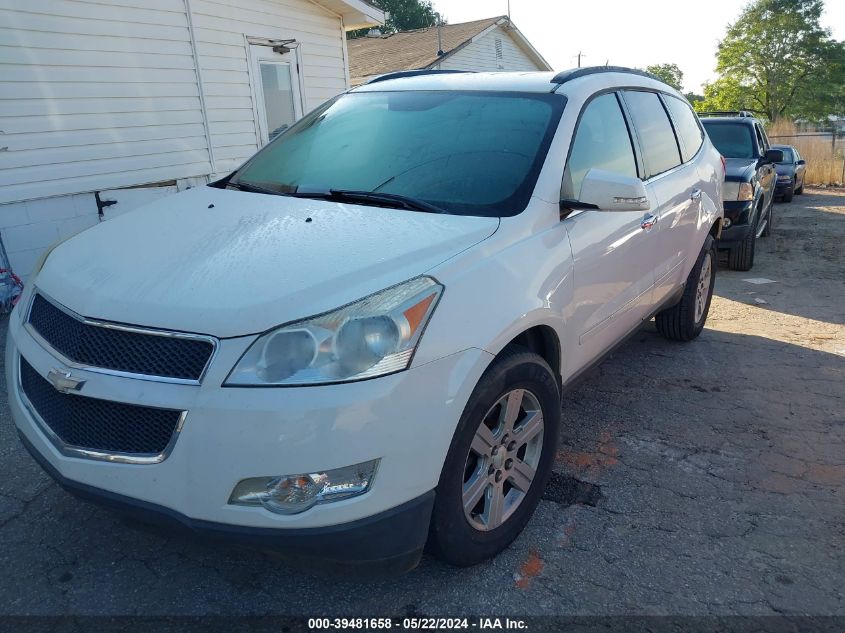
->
[696,0,845,121]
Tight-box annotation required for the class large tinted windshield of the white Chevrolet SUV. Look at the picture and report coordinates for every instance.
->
[230,91,565,216]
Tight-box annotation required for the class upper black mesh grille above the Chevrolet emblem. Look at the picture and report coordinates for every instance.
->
[29,294,214,380]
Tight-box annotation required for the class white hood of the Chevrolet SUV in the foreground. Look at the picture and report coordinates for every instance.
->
[35,187,499,337]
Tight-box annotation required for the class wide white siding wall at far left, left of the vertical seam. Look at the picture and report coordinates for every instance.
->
[0,0,210,205]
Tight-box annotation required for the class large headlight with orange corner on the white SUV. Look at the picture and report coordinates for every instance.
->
[225,277,443,387]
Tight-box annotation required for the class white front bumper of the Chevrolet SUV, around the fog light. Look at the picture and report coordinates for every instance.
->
[6,311,492,559]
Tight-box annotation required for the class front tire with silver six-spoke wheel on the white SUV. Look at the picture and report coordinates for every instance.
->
[427,346,560,567]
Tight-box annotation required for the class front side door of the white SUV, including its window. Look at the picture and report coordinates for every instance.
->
[561,93,657,368]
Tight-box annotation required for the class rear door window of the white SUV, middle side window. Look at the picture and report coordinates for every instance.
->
[625,90,681,178]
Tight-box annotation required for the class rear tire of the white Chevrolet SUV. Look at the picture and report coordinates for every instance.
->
[654,235,718,342]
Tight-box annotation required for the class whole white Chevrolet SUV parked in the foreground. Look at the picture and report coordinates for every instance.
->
[6,68,724,569]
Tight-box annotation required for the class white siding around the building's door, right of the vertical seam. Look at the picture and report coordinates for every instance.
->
[191,0,347,174]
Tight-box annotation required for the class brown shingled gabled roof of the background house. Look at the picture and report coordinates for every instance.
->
[347,15,551,85]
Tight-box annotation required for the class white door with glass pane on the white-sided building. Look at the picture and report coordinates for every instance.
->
[249,44,303,146]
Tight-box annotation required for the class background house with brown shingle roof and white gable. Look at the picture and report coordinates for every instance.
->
[349,16,552,86]
